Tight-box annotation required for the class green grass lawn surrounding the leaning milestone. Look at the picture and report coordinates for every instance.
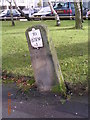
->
[2,20,88,84]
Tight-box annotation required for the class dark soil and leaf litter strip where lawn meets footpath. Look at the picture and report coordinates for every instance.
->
[1,71,88,96]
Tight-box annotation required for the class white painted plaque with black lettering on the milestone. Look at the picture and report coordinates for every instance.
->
[28,28,43,48]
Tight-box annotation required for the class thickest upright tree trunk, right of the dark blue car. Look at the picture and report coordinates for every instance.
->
[74,0,82,29]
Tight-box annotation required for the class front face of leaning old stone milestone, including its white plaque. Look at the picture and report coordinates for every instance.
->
[26,25,63,91]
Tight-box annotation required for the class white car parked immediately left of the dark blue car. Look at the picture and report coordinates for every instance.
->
[33,6,51,17]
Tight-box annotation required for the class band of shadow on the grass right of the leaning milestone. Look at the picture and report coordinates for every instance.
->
[56,42,88,59]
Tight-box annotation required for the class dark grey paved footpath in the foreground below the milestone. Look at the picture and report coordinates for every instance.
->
[2,84,88,118]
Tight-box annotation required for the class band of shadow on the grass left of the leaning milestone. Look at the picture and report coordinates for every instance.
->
[2,52,31,75]
